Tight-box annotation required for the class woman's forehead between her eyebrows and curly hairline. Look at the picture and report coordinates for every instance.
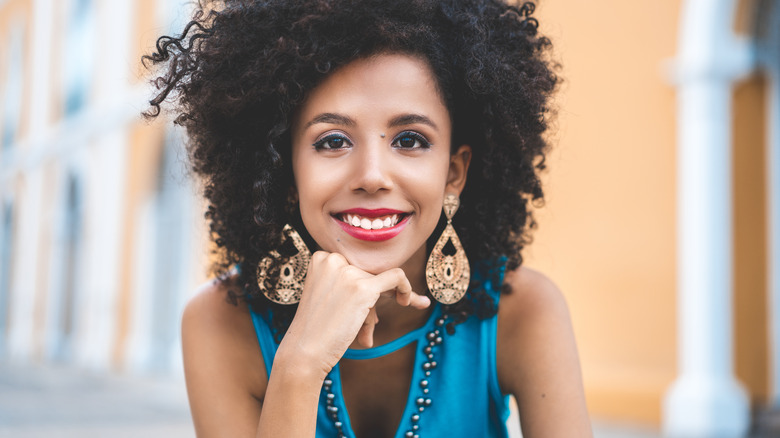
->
[296,54,450,126]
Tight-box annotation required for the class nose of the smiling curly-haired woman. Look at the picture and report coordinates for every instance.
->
[350,141,393,194]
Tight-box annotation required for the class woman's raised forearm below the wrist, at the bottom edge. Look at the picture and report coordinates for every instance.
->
[256,346,325,438]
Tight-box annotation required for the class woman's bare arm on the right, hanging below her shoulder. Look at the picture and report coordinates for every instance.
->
[496,267,593,438]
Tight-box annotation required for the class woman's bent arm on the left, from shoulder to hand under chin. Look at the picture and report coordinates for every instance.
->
[182,251,430,438]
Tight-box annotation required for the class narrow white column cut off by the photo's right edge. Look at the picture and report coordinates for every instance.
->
[763,0,780,407]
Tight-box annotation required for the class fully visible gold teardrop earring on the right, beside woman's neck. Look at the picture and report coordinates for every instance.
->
[425,195,471,304]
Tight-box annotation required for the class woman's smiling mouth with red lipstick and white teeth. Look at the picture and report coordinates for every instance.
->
[332,208,411,241]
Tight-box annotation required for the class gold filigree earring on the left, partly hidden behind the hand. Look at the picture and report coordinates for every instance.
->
[257,224,311,304]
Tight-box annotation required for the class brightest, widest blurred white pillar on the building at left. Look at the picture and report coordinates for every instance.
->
[77,0,134,369]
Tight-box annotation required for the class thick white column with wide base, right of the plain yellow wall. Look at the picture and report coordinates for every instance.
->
[663,0,753,438]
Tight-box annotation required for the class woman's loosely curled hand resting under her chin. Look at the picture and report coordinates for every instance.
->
[277,251,431,377]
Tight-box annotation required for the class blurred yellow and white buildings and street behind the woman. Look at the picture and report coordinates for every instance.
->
[0,0,780,438]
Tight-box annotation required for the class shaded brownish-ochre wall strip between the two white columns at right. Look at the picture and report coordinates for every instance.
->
[732,75,769,406]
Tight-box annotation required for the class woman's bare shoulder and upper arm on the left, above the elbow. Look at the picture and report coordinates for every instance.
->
[182,279,267,436]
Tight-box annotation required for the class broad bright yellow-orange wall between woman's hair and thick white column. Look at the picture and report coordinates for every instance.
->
[526,0,680,424]
